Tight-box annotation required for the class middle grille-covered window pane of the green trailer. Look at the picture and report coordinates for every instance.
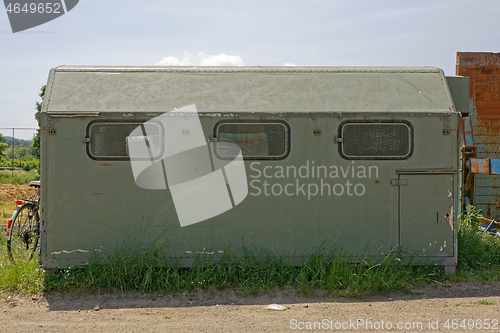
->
[214,121,290,160]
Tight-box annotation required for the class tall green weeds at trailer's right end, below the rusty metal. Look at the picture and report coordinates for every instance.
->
[457,206,500,280]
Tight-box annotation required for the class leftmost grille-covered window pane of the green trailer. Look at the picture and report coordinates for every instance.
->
[87,121,164,160]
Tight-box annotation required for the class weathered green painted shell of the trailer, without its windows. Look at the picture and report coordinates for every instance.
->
[39,67,460,269]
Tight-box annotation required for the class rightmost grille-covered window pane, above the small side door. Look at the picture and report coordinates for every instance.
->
[339,121,413,160]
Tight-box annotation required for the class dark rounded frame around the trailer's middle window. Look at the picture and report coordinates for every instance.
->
[213,119,292,161]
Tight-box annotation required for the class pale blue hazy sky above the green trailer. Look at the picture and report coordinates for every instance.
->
[0,0,500,139]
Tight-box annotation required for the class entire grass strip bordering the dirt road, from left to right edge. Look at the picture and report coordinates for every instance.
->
[0,207,500,294]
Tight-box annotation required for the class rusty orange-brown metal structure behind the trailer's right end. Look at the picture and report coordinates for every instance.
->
[456,52,500,218]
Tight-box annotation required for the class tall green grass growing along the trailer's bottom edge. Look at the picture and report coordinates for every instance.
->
[47,242,444,296]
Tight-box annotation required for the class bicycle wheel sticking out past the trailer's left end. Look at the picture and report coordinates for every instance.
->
[7,203,40,261]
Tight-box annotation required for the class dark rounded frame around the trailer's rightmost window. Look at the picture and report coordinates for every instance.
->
[337,119,415,160]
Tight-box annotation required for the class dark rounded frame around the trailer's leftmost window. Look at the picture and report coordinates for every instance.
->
[85,119,165,161]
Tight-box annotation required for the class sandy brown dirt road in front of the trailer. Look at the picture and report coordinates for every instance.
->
[0,282,500,332]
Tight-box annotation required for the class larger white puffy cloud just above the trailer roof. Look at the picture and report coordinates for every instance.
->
[156,52,245,66]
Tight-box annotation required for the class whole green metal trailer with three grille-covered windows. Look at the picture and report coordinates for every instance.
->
[38,66,468,272]
